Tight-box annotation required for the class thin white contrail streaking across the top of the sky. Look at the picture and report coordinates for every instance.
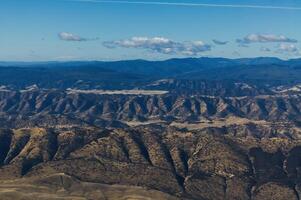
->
[66,0,301,10]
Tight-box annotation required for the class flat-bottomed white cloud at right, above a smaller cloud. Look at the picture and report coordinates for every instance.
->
[236,34,298,44]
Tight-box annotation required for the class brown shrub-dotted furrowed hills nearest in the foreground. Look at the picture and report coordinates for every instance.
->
[0,126,301,200]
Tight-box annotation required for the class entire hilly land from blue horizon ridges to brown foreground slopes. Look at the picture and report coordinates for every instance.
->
[0,58,301,200]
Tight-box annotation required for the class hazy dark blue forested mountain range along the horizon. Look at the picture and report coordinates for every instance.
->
[0,57,301,89]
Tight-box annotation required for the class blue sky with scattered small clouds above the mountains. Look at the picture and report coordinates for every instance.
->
[0,0,301,61]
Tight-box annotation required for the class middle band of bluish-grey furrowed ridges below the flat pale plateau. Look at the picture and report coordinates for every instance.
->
[0,90,301,127]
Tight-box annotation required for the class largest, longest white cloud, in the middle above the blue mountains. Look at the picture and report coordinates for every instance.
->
[103,37,211,56]
